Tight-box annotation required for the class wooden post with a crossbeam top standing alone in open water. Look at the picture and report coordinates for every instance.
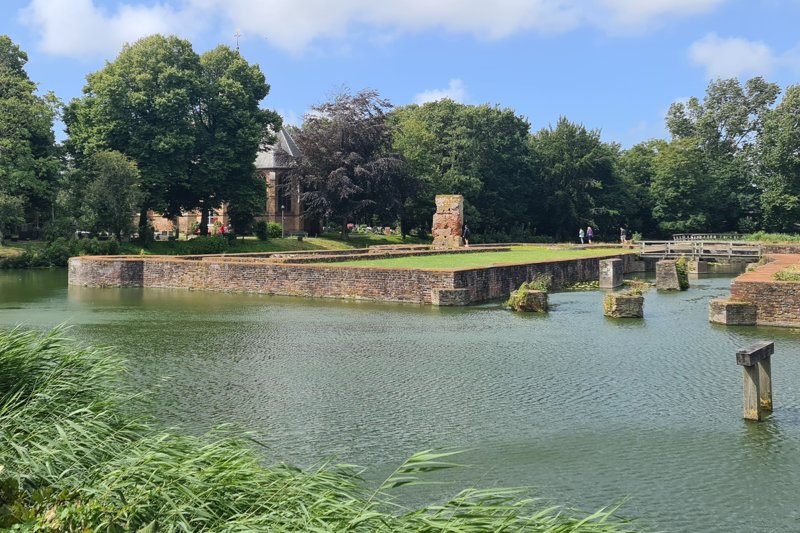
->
[736,341,775,420]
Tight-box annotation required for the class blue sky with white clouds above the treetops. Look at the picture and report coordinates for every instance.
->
[0,0,800,147]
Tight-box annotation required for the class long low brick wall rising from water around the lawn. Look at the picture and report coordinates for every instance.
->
[69,255,635,304]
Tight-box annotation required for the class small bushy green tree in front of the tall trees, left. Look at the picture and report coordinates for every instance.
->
[81,151,142,240]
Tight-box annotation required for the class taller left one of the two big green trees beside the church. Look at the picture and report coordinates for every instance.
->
[64,35,201,226]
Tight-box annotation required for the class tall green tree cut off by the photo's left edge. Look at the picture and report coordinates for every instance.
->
[0,35,59,229]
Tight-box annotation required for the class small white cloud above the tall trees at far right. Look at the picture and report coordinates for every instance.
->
[689,33,781,78]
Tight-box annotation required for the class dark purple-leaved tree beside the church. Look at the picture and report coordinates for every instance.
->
[288,90,414,236]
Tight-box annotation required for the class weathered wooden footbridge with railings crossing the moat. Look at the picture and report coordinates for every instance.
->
[636,239,761,261]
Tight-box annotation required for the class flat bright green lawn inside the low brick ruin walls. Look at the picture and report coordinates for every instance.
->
[336,246,632,269]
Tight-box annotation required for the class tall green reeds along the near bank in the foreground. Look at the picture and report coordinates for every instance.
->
[0,329,633,533]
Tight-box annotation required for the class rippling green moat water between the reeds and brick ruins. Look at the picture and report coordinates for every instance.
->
[0,271,800,532]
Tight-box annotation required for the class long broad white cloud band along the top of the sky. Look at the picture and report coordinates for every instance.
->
[20,0,727,57]
